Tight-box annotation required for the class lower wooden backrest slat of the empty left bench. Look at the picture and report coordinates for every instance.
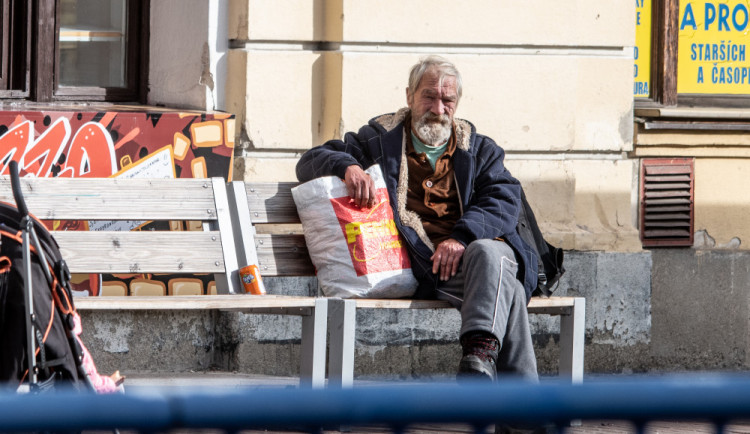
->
[52,231,225,273]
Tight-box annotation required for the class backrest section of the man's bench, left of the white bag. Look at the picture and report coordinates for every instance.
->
[229,182,315,277]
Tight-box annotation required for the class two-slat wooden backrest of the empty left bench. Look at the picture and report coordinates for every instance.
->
[0,177,241,293]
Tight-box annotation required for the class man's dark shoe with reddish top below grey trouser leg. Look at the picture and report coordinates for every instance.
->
[456,332,500,381]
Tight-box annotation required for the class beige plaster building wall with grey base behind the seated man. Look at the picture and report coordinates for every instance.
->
[126,0,750,375]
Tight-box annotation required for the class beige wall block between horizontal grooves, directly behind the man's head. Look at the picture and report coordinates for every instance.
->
[341,52,633,152]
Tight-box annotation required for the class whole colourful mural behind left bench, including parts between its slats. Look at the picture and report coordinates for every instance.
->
[0,111,235,295]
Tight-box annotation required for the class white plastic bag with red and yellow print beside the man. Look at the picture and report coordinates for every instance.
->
[292,164,417,298]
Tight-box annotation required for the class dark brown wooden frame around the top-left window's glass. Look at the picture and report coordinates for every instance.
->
[0,0,150,104]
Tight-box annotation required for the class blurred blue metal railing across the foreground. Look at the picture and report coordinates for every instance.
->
[0,375,750,431]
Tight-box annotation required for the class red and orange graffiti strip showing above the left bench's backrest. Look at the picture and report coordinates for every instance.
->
[0,111,234,179]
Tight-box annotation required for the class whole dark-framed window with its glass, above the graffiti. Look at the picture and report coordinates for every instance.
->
[0,0,148,102]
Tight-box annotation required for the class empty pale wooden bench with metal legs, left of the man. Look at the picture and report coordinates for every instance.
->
[0,177,328,387]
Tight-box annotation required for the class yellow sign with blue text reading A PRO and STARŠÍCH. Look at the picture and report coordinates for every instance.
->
[677,0,750,95]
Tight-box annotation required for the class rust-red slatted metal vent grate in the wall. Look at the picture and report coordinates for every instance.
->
[640,158,694,247]
